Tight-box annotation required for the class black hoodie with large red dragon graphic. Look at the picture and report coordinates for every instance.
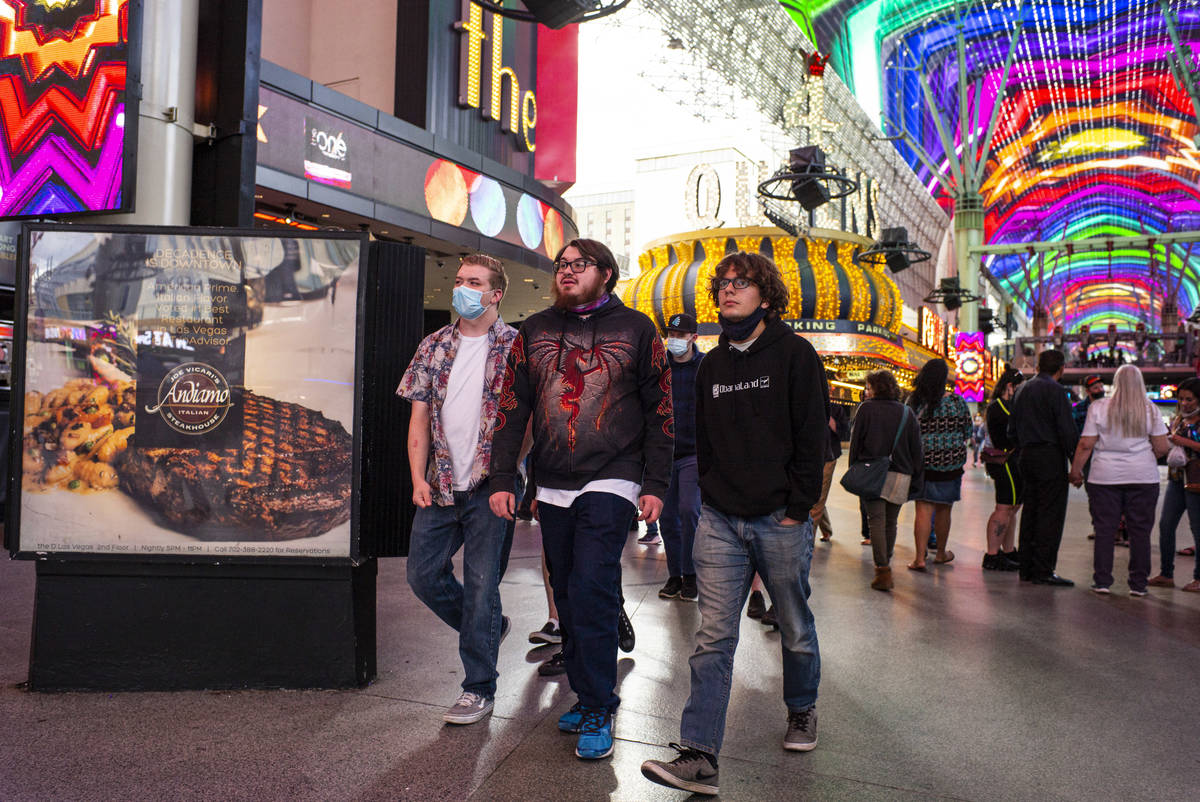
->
[490,295,674,498]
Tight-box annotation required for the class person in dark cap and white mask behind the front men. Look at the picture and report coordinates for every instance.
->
[659,312,704,602]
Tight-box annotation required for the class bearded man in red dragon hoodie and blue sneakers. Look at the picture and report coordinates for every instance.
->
[491,239,674,759]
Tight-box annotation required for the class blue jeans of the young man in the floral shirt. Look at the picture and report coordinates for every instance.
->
[408,483,504,699]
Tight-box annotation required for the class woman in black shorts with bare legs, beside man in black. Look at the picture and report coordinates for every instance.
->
[983,367,1025,570]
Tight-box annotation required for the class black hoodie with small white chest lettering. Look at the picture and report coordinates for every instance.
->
[696,316,829,521]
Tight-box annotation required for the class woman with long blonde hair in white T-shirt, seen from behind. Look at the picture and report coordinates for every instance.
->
[1068,365,1170,597]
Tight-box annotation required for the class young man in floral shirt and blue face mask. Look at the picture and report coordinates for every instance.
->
[396,253,517,724]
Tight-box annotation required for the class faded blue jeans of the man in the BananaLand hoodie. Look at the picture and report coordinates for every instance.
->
[679,504,821,755]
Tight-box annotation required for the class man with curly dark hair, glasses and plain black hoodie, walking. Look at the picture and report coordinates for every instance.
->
[642,252,829,794]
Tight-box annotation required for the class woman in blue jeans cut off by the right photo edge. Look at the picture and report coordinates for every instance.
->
[1150,378,1200,593]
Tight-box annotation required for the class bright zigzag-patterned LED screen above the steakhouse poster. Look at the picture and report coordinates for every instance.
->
[0,0,142,219]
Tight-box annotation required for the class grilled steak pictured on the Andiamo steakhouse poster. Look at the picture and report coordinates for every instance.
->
[119,390,353,540]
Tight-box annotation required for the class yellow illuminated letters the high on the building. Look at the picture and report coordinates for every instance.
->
[455,0,538,151]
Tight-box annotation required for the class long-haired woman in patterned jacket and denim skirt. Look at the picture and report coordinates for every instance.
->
[908,359,971,570]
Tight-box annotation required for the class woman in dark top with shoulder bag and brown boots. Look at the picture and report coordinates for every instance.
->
[850,370,923,591]
